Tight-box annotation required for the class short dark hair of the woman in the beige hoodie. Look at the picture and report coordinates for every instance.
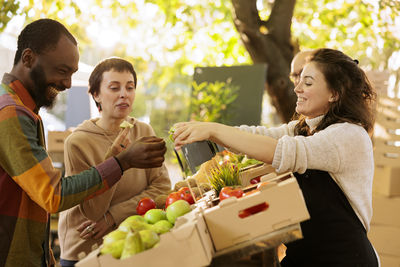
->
[88,57,137,111]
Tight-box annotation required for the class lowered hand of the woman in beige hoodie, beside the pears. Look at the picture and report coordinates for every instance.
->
[76,212,114,240]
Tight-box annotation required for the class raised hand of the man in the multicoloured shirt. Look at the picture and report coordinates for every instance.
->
[115,136,167,171]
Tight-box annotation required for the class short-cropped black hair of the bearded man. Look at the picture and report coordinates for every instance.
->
[14,19,78,66]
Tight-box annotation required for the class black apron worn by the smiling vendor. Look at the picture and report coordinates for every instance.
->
[281,170,378,267]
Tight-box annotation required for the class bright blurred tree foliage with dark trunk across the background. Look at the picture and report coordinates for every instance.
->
[0,0,400,126]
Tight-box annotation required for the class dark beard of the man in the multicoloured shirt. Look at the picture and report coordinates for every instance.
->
[29,65,65,108]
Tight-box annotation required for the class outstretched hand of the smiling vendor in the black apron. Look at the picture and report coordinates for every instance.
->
[173,121,219,149]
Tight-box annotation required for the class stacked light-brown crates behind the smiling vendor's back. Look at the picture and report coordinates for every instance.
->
[368,96,400,267]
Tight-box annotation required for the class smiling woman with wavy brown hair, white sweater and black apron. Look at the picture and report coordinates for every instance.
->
[174,48,379,266]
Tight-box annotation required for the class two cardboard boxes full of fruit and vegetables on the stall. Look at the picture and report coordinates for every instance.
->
[76,151,309,267]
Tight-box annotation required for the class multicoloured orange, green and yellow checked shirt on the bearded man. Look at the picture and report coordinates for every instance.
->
[0,74,122,267]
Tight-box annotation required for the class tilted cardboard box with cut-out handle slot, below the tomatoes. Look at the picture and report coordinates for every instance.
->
[204,173,310,252]
